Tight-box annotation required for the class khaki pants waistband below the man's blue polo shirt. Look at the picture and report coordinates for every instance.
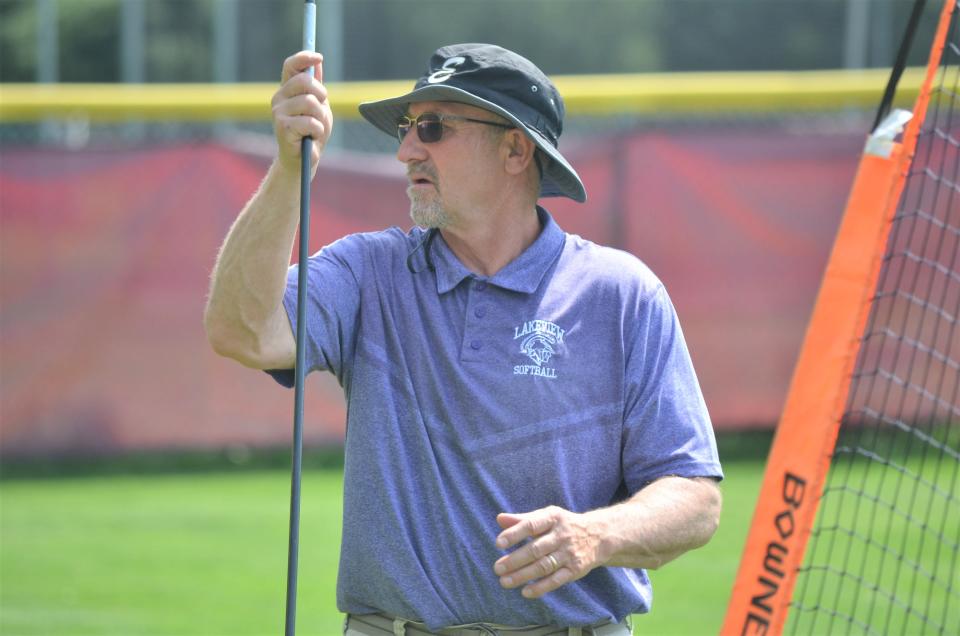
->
[343,614,632,636]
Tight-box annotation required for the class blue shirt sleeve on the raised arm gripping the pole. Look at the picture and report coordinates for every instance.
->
[267,235,365,387]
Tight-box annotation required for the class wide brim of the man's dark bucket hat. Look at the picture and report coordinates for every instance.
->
[360,85,587,203]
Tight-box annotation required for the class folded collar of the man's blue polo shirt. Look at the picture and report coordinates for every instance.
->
[433,206,566,294]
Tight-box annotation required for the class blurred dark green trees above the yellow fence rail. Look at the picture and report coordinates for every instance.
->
[0,0,937,82]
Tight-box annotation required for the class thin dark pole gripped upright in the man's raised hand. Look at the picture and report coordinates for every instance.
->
[285,0,317,636]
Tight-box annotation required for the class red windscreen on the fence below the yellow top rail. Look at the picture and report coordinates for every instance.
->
[0,124,864,456]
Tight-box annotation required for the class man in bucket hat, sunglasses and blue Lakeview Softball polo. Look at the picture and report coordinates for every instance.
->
[205,44,722,634]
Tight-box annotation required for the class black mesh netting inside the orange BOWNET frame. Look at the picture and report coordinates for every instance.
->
[787,3,960,634]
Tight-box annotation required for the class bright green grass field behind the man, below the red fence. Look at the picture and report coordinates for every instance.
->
[0,459,763,636]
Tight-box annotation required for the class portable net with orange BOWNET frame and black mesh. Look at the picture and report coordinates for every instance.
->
[723,0,960,634]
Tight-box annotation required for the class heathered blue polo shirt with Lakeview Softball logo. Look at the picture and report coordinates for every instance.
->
[273,208,722,629]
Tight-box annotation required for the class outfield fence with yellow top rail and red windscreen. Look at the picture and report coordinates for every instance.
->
[0,71,920,456]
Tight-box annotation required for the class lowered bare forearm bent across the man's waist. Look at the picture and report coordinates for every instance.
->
[587,477,721,569]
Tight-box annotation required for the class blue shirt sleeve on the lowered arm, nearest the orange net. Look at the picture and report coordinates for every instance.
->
[622,285,723,494]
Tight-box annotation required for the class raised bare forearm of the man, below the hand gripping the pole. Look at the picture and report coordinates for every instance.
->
[204,162,300,368]
